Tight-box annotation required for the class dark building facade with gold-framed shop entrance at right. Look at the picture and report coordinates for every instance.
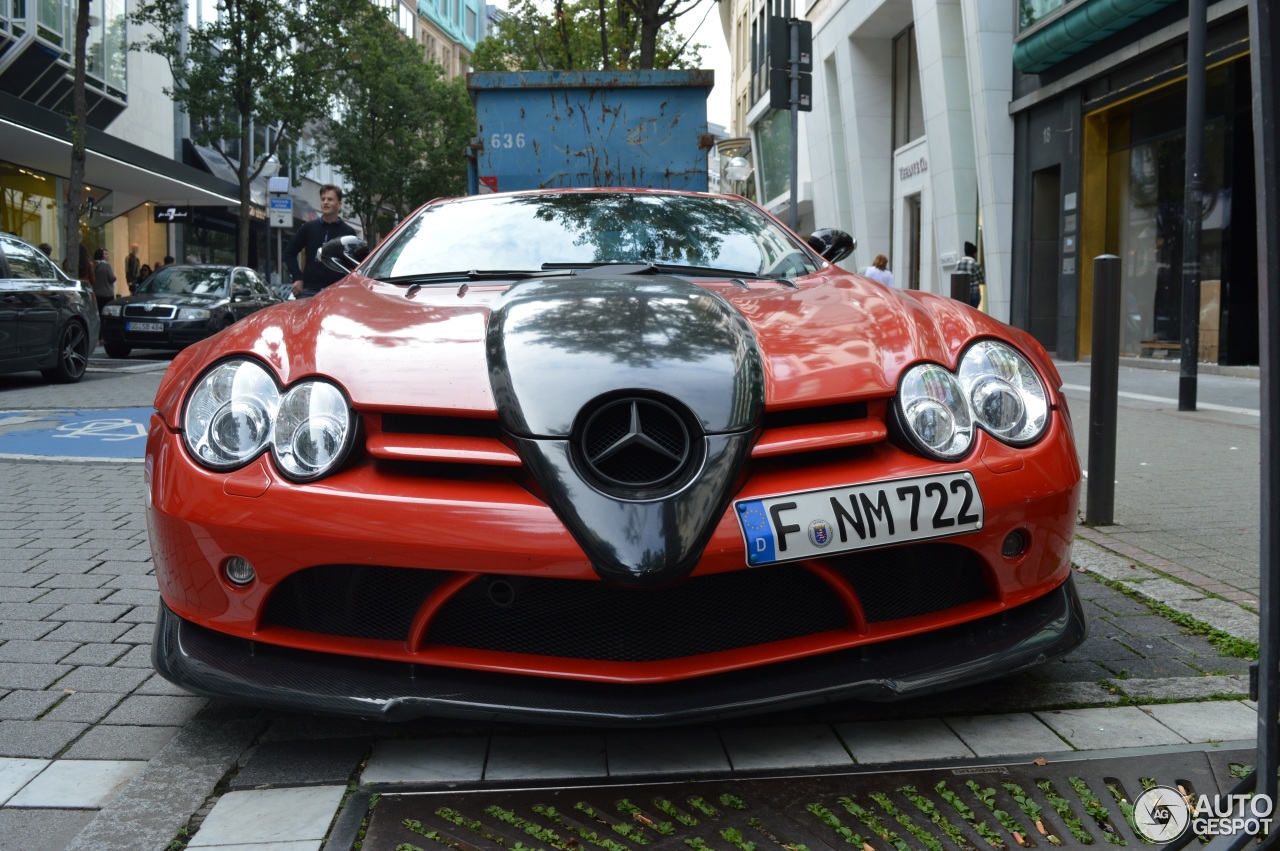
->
[1009,0,1258,365]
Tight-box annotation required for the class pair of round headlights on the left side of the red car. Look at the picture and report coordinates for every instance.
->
[183,358,355,481]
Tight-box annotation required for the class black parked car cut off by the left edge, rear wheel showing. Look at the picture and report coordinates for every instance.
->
[0,234,99,384]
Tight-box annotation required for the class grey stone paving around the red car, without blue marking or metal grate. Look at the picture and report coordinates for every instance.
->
[0,353,1258,851]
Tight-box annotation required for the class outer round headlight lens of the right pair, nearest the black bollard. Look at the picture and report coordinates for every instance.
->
[960,340,1048,444]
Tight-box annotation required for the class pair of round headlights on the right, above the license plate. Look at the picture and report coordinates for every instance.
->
[897,340,1048,461]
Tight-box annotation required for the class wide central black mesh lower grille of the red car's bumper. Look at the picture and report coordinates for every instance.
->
[428,566,847,662]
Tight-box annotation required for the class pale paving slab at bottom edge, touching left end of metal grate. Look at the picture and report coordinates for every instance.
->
[187,786,347,848]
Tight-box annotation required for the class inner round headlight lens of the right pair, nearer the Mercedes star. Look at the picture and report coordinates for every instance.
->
[897,363,973,461]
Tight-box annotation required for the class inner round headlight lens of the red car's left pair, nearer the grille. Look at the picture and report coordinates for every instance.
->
[273,381,352,480]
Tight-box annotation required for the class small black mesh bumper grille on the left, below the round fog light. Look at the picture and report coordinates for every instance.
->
[262,564,451,641]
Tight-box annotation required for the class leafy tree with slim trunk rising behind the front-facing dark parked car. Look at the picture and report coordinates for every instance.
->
[133,0,369,264]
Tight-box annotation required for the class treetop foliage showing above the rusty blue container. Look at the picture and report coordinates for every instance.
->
[471,0,707,70]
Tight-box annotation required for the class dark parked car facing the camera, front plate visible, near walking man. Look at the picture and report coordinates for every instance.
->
[102,265,280,357]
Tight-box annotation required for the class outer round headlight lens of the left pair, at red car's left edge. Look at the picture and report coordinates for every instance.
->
[183,360,280,470]
